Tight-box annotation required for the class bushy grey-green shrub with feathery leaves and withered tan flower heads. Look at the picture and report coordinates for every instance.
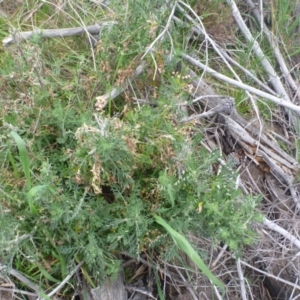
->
[1,106,258,286]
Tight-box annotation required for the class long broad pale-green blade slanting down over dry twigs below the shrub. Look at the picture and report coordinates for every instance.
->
[154,216,225,292]
